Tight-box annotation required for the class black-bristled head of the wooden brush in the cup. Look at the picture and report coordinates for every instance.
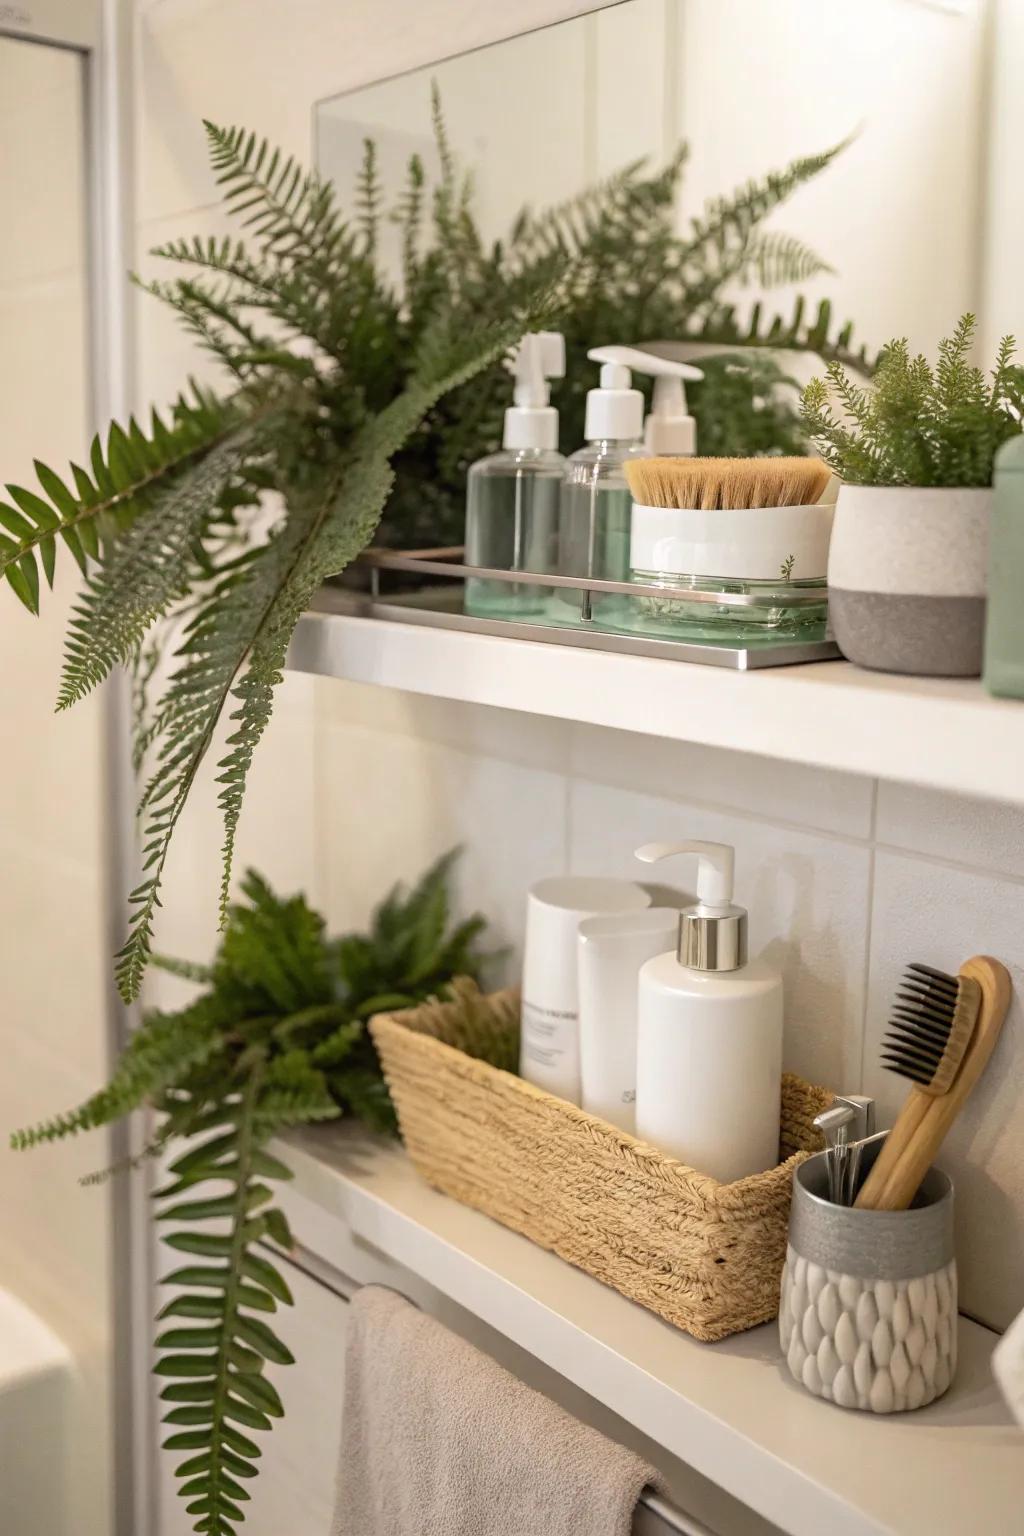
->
[881,965,981,1097]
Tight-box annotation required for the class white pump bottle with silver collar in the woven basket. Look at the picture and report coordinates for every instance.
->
[636,842,783,1184]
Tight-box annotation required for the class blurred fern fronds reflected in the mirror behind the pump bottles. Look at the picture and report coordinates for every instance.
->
[378,109,870,548]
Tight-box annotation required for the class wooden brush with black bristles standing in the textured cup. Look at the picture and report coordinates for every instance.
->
[855,955,1012,1210]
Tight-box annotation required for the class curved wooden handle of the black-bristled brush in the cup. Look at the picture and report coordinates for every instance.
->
[857,955,1013,1210]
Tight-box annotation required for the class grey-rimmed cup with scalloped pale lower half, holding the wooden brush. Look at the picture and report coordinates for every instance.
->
[778,1135,956,1413]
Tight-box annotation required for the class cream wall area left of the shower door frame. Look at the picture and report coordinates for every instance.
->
[0,27,111,1536]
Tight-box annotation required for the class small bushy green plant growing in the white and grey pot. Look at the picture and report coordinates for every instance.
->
[803,315,1024,485]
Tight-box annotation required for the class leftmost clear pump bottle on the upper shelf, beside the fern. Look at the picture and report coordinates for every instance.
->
[465,330,565,619]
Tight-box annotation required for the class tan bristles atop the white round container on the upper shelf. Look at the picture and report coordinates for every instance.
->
[625,458,832,511]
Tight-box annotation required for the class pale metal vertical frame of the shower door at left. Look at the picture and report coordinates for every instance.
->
[0,0,145,1536]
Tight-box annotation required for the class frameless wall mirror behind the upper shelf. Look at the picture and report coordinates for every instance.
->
[316,0,1007,552]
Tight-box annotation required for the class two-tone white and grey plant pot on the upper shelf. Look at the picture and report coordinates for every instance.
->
[829,485,992,677]
